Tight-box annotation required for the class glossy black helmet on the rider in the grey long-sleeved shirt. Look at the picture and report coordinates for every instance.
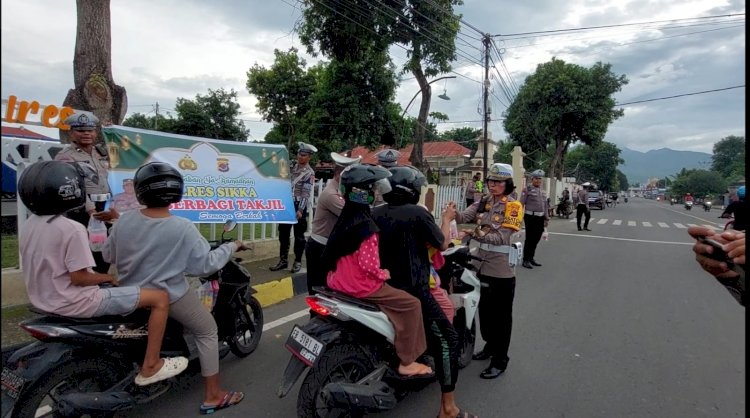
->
[133,162,185,207]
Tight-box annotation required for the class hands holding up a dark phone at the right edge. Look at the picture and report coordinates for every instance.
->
[688,226,746,306]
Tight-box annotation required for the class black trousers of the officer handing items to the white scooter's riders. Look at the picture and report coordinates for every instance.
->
[479,274,516,369]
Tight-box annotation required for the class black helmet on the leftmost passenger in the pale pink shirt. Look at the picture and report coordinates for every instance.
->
[18,161,86,215]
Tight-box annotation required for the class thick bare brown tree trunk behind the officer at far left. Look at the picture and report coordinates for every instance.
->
[60,0,128,143]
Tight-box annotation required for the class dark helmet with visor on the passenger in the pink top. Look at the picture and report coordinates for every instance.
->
[339,164,391,205]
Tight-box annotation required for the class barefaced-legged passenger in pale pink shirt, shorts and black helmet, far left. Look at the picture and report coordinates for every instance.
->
[18,161,188,386]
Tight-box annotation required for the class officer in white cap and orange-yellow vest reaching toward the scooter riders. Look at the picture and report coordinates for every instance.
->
[456,164,523,379]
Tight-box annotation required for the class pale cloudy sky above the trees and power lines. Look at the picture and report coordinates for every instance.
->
[0,0,745,153]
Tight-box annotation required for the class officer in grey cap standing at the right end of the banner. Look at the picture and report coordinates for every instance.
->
[271,142,318,273]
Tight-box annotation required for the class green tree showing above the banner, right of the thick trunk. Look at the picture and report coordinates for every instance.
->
[173,88,250,142]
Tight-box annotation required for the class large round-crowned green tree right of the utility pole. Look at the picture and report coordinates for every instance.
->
[504,58,628,179]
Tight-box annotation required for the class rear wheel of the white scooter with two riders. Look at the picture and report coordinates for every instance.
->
[297,344,375,418]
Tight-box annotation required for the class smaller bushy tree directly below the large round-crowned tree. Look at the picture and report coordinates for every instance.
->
[565,141,627,191]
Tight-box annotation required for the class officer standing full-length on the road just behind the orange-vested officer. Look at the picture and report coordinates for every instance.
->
[521,170,549,269]
